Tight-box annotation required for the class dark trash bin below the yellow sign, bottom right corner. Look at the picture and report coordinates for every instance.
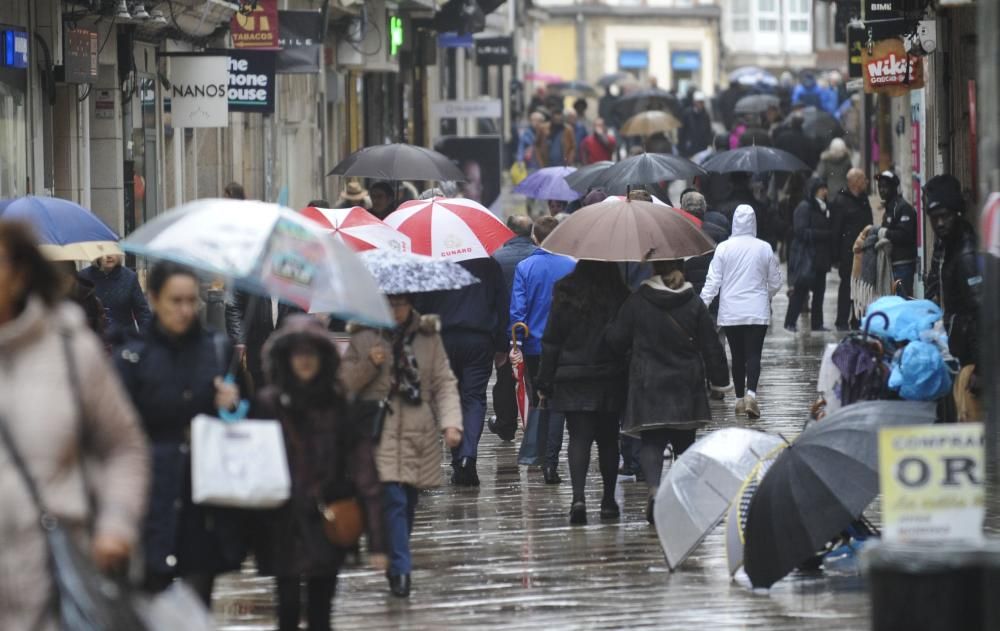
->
[862,542,988,631]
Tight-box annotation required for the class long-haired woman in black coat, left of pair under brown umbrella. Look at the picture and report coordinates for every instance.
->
[535,260,629,524]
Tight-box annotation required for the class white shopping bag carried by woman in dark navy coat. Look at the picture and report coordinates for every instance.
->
[191,414,292,508]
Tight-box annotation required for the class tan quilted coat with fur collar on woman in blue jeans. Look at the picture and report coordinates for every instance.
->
[340,316,462,489]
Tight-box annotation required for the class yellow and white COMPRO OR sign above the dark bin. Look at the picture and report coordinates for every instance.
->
[878,423,986,541]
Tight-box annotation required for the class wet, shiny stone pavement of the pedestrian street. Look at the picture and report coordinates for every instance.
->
[216,275,869,631]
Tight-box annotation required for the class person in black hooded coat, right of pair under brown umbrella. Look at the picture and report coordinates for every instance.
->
[605,261,729,523]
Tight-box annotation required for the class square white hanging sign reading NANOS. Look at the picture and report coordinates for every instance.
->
[170,55,229,127]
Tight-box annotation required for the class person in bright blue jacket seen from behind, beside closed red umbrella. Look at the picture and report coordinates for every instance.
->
[510,217,576,484]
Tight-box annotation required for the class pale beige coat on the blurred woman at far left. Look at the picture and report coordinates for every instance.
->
[0,298,149,629]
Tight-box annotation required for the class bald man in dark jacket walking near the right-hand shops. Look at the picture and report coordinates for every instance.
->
[830,169,872,331]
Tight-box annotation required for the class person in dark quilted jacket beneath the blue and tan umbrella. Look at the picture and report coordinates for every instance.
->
[80,254,153,338]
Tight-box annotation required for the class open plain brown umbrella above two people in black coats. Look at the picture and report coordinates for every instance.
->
[542,199,715,262]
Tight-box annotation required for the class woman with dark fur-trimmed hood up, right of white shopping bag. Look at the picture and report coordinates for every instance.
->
[251,315,386,631]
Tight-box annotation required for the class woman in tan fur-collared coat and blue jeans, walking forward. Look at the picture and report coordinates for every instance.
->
[341,295,462,598]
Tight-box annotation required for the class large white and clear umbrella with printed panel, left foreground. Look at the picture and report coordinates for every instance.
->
[122,199,394,326]
